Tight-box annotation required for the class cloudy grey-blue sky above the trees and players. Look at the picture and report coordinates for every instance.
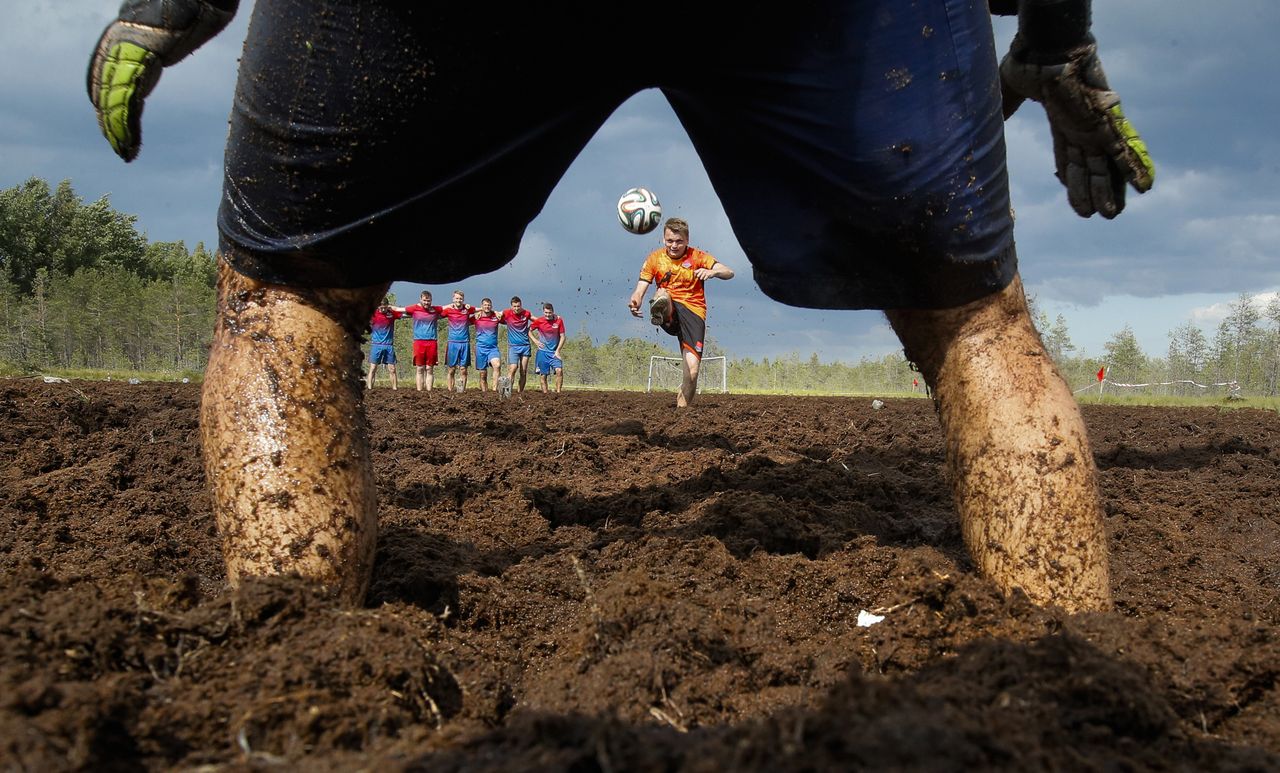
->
[0,0,1280,371]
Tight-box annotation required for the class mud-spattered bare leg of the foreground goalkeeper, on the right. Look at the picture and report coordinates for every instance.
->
[888,278,1111,612]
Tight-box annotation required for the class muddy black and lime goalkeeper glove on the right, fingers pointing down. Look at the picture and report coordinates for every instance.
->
[1000,36,1156,219]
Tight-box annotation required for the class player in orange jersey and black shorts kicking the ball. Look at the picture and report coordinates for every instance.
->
[627,218,733,408]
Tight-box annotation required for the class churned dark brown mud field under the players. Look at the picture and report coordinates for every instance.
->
[0,380,1280,772]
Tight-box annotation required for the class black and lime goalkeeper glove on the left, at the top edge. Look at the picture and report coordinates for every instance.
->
[88,0,238,161]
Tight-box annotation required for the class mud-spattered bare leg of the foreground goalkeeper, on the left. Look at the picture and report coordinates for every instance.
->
[200,264,387,604]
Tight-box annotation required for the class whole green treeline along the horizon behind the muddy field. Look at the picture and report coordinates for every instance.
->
[0,178,1280,397]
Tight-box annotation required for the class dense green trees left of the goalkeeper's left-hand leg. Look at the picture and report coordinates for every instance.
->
[0,178,216,372]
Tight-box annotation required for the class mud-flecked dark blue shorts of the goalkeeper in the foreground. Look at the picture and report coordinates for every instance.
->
[225,0,1016,308]
